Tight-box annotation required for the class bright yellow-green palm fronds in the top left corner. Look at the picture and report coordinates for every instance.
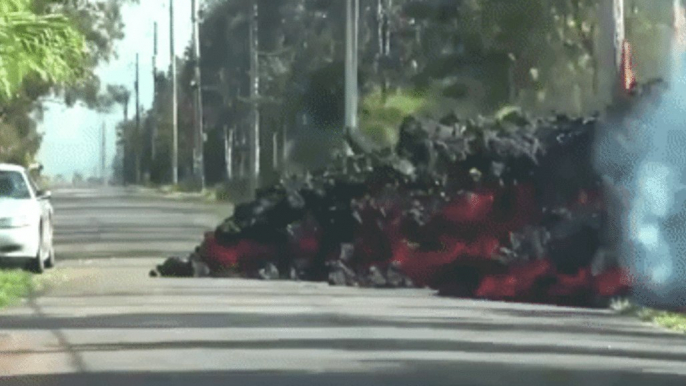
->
[0,0,86,100]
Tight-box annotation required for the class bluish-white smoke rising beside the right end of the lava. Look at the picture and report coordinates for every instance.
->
[595,0,686,309]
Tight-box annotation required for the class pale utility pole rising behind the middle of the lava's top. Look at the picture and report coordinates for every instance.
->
[345,0,360,153]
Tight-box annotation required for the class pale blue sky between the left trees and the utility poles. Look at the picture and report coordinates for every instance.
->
[38,0,192,177]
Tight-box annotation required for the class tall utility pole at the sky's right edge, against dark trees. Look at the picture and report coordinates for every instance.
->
[191,0,205,190]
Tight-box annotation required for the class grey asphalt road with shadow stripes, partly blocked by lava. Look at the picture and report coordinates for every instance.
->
[0,190,686,386]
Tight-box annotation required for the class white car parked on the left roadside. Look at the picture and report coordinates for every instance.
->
[0,164,55,273]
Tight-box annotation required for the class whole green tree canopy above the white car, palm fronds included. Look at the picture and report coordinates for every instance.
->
[0,0,137,164]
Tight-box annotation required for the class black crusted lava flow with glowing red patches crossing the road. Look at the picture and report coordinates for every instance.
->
[152,110,644,306]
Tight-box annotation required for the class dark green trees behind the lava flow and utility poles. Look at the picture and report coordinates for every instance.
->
[140,0,671,184]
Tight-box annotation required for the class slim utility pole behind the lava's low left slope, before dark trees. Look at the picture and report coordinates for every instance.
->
[248,0,260,194]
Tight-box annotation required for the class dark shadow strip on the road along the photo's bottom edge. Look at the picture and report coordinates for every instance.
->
[5,363,684,386]
